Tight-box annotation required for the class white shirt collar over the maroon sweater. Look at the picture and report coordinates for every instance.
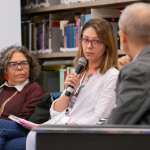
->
[0,79,30,92]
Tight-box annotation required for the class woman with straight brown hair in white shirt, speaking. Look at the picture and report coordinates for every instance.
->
[26,18,119,150]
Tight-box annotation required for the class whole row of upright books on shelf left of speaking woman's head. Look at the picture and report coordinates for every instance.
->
[21,14,91,54]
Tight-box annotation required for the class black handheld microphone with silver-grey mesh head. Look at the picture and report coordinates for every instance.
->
[65,57,87,97]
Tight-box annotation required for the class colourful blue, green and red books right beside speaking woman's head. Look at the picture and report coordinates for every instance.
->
[60,14,91,52]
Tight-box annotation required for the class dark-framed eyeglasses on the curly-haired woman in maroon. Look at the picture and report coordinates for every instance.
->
[8,61,29,70]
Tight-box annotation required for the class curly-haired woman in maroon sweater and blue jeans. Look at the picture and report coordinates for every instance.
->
[0,46,45,150]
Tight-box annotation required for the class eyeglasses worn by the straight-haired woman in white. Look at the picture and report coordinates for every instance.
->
[80,38,103,47]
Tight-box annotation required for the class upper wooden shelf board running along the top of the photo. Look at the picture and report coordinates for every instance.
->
[21,0,144,16]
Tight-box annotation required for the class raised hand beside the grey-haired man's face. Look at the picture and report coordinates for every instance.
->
[118,55,132,70]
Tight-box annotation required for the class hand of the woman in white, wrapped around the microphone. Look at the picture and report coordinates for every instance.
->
[64,72,80,89]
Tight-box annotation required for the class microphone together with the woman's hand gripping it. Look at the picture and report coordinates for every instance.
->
[65,57,87,97]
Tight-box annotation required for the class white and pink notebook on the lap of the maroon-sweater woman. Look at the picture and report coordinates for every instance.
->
[8,115,37,130]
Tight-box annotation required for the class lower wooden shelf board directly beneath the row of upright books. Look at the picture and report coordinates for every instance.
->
[35,50,125,59]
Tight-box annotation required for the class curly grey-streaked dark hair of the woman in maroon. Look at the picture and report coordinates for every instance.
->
[0,45,41,85]
